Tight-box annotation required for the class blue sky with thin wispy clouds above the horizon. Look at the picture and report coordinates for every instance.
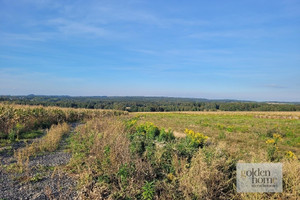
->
[0,0,300,101]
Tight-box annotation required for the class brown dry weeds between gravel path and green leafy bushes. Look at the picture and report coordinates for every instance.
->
[69,118,153,199]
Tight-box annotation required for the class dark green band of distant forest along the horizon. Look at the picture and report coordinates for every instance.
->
[0,95,300,112]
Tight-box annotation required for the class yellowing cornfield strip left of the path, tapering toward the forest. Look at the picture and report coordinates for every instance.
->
[0,104,126,139]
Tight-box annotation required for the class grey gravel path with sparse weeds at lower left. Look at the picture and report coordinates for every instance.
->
[0,124,77,200]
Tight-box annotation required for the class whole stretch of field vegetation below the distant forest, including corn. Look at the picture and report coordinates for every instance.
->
[0,104,300,200]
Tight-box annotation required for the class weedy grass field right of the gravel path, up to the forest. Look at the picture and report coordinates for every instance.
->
[68,112,300,199]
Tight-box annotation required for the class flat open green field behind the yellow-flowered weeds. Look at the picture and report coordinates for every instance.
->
[134,112,300,159]
